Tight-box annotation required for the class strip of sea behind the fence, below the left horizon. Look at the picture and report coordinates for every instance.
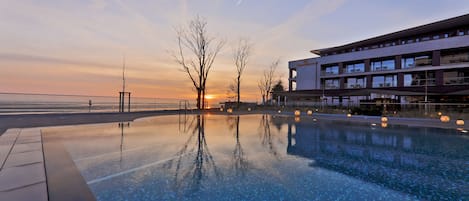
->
[0,93,195,115]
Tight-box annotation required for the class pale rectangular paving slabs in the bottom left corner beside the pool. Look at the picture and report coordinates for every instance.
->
[0,128,48,201]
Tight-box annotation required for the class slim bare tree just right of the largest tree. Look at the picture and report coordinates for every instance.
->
[233,38,251,108]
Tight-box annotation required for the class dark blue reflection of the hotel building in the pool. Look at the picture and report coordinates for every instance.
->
[287,119,469,200]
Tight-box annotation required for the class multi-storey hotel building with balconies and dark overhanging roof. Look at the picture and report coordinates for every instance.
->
[284,14,469,105]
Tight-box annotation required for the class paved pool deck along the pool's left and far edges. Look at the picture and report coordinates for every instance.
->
[0,111,469,201]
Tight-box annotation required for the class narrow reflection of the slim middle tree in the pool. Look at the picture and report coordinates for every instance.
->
[227,115,249,176]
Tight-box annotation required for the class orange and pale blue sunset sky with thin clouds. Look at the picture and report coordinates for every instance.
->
[0,0,469,101]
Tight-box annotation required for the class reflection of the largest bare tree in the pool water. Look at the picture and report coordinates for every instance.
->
[165,115,220,194]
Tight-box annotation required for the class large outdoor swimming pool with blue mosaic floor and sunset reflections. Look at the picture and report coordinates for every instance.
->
[43,115,469,200]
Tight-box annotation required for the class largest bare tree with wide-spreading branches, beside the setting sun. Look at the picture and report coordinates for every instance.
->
[173,16,225,109]
